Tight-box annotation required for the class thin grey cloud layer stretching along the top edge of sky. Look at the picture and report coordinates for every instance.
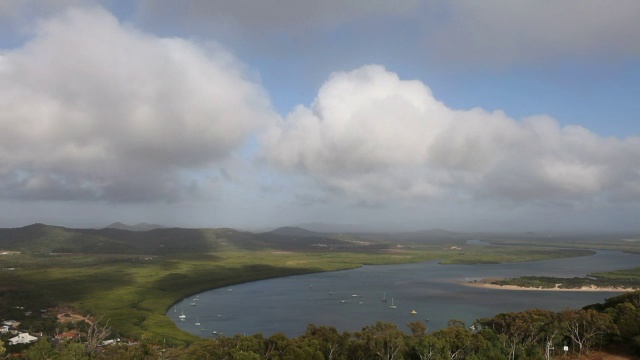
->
[136,0,640,69]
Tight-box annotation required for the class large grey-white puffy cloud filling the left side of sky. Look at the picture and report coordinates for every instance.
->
[0,8,275,202]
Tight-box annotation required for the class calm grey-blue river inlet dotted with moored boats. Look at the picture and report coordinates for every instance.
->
[167,251,640,337]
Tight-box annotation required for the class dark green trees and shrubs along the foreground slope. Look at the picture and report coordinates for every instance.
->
[5,292,640,360]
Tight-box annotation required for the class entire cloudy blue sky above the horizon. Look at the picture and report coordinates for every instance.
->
[0,0,640,232]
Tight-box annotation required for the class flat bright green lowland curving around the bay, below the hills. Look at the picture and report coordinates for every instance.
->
[0,225,638,345]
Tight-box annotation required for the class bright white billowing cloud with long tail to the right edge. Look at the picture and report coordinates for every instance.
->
[263,65,640,203]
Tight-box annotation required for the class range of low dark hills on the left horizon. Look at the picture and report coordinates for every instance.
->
[0,223,386,255]
